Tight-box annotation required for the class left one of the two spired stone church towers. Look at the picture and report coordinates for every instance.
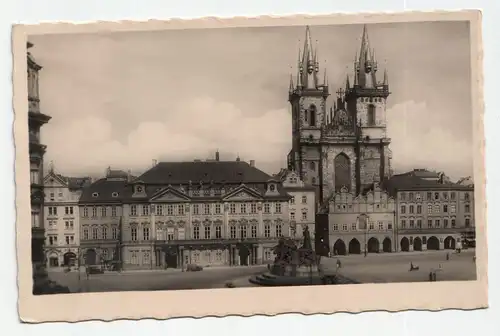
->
[288,27,330,200]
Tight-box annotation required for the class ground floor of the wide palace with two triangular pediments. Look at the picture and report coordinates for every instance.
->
[122,241,278,269]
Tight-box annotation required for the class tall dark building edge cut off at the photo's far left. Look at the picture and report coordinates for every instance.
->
[27,42,50,278]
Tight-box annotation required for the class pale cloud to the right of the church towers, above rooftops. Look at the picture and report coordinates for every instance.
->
[387,101,473,179]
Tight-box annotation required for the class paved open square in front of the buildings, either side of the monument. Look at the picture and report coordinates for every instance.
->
[49,250,476,292]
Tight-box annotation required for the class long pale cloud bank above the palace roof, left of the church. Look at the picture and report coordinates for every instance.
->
[43,96,291,174]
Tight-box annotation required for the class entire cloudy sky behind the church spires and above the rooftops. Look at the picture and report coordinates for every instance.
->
[29,22,472,179]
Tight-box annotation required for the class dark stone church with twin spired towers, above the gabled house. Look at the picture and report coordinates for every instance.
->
[288,26,392,203]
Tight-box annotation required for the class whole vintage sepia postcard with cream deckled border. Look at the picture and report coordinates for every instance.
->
[13,11,488,322]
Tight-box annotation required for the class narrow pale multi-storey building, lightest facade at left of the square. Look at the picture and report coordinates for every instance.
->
[44,165,91,268]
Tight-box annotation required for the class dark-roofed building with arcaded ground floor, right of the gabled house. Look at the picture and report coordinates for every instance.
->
[387,170,475,251]
